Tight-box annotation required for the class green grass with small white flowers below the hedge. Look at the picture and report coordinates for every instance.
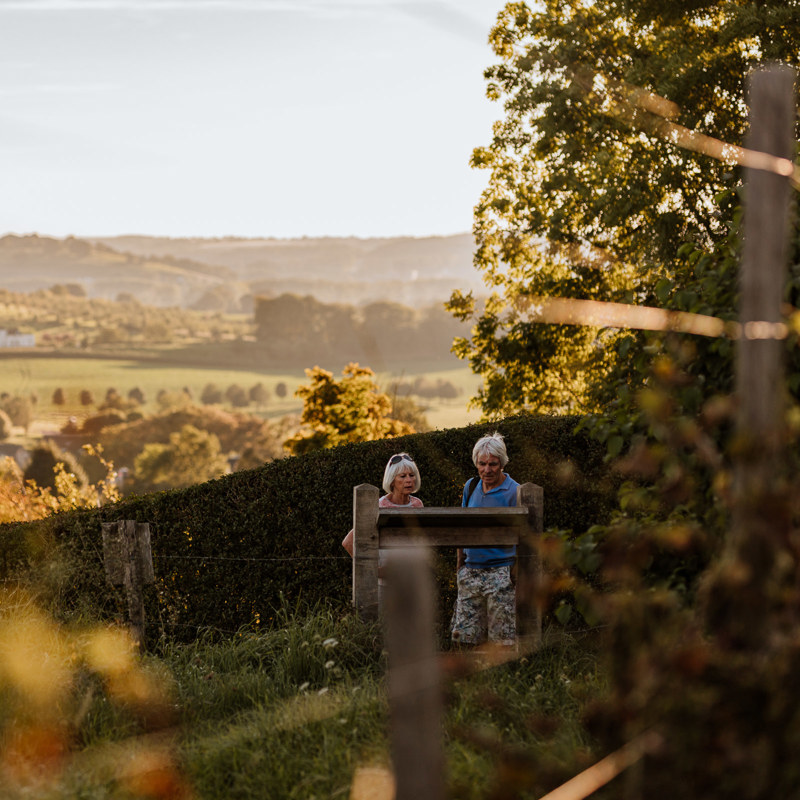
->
[0,608,603,800]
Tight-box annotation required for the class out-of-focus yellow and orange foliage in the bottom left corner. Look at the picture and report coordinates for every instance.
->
[0,589,188,800]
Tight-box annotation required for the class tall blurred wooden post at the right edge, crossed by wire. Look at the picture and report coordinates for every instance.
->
[720,66,795,648]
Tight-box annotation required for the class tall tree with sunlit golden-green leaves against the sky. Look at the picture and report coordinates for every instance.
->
[449,0,800,415]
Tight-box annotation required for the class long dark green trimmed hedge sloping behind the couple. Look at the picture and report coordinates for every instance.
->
[0,415,616,639]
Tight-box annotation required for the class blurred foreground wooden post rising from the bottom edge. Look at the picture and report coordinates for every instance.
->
[384,546,444,800]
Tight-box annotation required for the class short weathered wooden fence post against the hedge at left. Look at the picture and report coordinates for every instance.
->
[102,519,155,648]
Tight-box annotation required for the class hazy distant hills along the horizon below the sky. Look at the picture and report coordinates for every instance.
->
[0,234,482,313]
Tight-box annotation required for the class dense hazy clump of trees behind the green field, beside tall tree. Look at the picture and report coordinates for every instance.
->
[254,294,468,371]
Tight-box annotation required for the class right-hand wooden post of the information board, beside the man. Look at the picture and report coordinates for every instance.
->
[517,483,544,653]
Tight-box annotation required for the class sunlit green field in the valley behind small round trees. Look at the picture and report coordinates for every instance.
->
[0,356,479,428]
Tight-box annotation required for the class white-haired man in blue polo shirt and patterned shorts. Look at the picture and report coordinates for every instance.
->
[451,433,519,646]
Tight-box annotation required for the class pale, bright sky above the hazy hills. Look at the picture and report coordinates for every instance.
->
[0,0,504,238]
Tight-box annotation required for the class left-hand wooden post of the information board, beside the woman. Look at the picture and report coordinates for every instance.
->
[353,483,380,620]
